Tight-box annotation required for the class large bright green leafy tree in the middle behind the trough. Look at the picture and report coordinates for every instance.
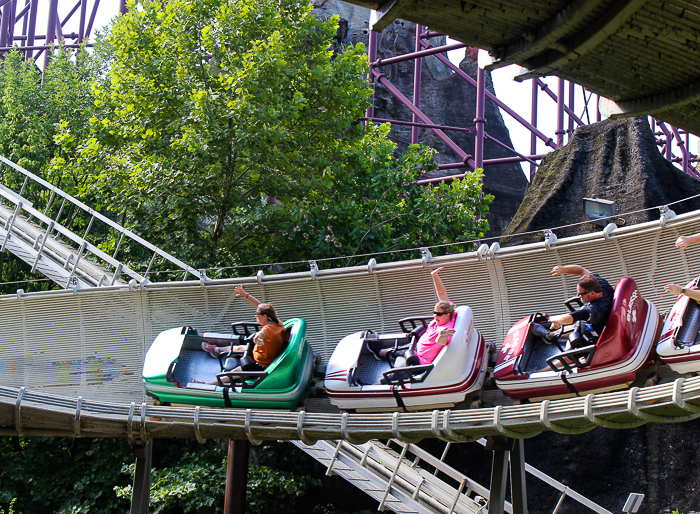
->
[64,0,490,274]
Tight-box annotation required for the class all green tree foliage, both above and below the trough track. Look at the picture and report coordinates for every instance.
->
[0,0,491,508]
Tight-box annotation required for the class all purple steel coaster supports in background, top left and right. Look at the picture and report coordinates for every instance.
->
[0,0,700,184]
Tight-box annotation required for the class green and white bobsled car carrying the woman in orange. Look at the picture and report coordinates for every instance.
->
[142,318,314,410]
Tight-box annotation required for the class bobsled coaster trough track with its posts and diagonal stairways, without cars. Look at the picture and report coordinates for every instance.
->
[0,159,700,512]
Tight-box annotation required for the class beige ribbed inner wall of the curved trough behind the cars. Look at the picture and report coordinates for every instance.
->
[0,202,700,404]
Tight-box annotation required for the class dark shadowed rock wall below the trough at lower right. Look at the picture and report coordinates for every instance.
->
[420,420,700,514]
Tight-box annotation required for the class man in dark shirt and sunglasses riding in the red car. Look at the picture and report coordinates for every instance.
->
[532,264,614,341]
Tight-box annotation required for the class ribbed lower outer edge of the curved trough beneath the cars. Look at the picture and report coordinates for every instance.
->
[0,377,700,445]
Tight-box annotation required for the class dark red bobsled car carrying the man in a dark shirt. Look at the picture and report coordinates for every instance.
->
[494,277,661,399]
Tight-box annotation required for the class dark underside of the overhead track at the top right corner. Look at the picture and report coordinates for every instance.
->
[350,0,700,134]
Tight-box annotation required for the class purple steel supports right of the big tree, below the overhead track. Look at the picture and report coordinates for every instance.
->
[364,25,700,185]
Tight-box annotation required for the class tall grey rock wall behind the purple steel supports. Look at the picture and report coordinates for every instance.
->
[314,0,528,236]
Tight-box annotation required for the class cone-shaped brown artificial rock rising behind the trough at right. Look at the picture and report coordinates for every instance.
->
[501,117,700,246]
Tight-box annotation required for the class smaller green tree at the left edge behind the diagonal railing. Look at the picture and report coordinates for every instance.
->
[0,47,97,293]
